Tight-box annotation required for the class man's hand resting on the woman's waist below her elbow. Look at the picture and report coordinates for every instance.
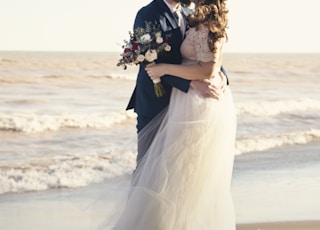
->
[190,72,227,100]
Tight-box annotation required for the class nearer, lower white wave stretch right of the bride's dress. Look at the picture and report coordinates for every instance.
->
[236,129,320,155]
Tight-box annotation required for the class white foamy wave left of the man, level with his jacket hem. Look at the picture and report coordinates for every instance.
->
[0,111,135,133]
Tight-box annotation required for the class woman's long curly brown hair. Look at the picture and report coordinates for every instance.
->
[189,0,229,52]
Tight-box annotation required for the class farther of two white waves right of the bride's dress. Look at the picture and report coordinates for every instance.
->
[236,98,320,117]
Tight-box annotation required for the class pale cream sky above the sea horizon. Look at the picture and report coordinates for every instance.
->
[0,0,320,53]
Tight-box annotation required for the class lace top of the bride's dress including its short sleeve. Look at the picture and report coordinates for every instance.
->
[181,26,224,72]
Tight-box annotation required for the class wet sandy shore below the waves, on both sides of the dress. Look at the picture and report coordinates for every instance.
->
[0,142,320,230]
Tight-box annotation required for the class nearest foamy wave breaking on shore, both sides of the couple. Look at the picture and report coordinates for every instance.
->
[0,129,320,194]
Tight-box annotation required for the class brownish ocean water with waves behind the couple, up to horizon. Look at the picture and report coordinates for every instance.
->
[0,52,320,196]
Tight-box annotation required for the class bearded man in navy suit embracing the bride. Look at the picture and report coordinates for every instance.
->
[127,0,224,162]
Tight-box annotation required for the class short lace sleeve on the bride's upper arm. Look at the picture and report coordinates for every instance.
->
[194,27,215,62]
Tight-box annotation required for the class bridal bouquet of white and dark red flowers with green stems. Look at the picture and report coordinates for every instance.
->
[117,22,171,97]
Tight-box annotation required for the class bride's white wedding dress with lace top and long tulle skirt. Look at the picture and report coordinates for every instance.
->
[113,25,236,230]
